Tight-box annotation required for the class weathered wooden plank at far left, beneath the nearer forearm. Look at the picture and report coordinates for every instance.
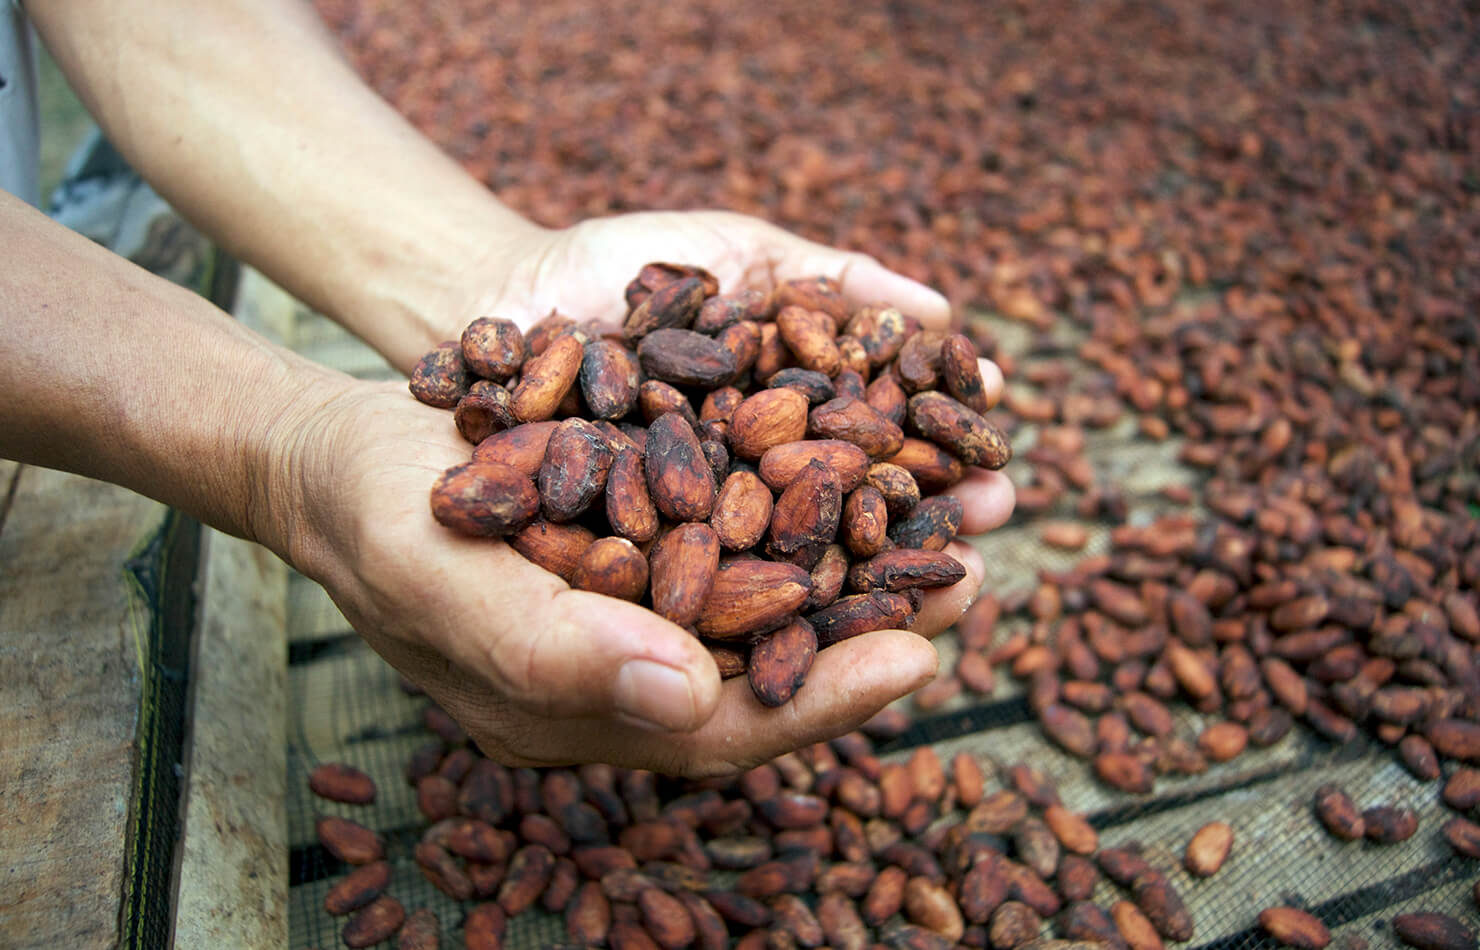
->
[0,466,164,949]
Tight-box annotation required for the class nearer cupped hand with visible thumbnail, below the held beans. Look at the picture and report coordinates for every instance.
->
[290,371,1011,777]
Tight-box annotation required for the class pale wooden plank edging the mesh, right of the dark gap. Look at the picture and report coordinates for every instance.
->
[175,531,289,947]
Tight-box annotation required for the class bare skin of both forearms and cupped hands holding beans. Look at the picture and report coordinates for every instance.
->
[0,0,1012,775]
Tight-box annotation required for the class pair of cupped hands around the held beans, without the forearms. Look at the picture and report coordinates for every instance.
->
[300,205,1012,777]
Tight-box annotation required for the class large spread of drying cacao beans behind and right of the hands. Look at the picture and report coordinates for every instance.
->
[303,0,1480,947]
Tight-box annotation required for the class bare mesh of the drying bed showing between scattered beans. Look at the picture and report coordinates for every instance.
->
[289,307,1477,950]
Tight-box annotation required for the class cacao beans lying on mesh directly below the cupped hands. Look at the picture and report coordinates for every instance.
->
[309,706,1233,950]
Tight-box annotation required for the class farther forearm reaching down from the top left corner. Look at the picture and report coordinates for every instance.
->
[27,0,539,370]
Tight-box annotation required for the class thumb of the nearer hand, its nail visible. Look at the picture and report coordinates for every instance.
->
[482,568,719,732]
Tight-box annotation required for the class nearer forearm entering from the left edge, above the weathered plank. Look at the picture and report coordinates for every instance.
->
[0,192,338,556]
